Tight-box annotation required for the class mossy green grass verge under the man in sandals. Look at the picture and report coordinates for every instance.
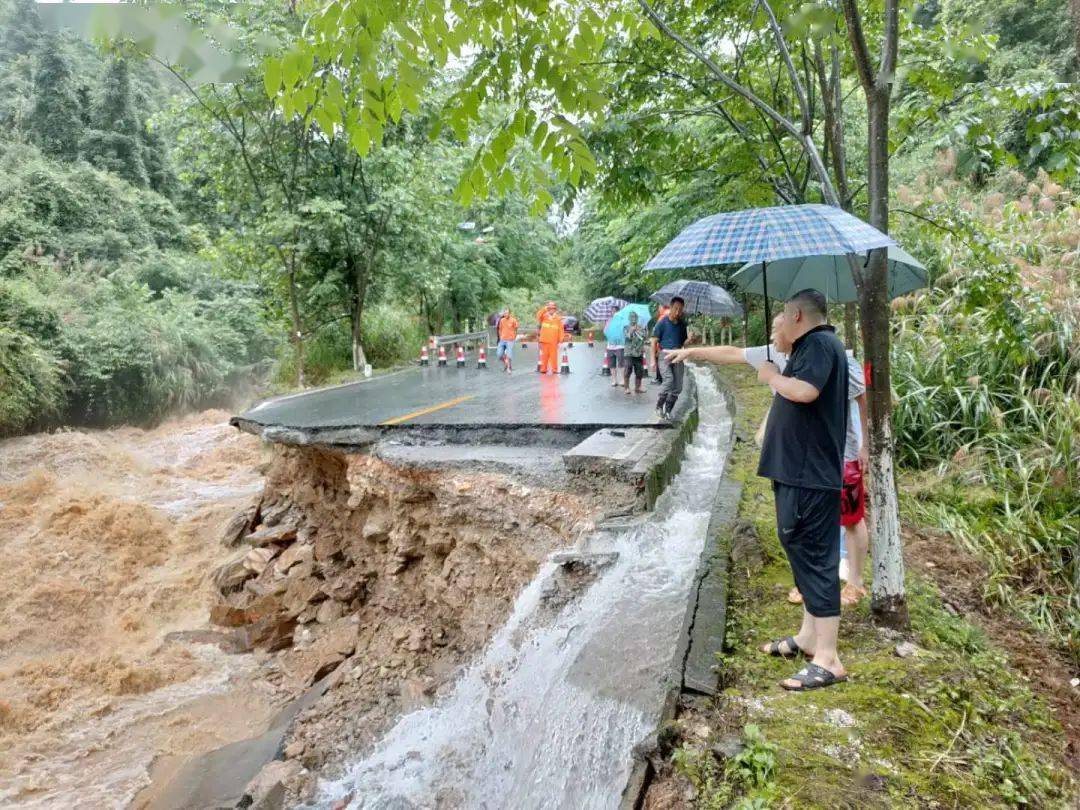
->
[674,369,1076,808]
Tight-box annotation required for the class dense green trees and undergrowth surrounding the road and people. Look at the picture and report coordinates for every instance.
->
[0,0,1080,656]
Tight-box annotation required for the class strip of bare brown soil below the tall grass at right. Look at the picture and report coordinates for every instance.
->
[904,527,1080,774]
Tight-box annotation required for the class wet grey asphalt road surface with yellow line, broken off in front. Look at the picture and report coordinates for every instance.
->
[240,343,659,429]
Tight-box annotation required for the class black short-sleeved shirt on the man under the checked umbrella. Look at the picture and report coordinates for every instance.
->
[757,325,848,489]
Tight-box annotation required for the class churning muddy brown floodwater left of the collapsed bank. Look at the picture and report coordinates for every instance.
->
[0,411,287,808]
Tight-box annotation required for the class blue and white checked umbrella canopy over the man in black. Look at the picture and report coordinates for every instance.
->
[645,204,896,270]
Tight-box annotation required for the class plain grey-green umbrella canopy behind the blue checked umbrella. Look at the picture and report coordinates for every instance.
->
[731,245,927,303]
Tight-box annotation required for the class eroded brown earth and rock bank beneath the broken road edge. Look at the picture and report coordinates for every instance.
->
[154,446,640,805]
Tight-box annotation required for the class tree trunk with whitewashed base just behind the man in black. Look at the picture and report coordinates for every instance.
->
[856,84,909,627]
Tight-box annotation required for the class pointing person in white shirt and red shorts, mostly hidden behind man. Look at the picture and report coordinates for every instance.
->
[664,315,869,606]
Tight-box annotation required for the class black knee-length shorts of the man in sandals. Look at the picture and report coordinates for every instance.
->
[772,481,840,619]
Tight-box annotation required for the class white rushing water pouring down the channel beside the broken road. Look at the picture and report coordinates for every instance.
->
[318,369,729,810]
